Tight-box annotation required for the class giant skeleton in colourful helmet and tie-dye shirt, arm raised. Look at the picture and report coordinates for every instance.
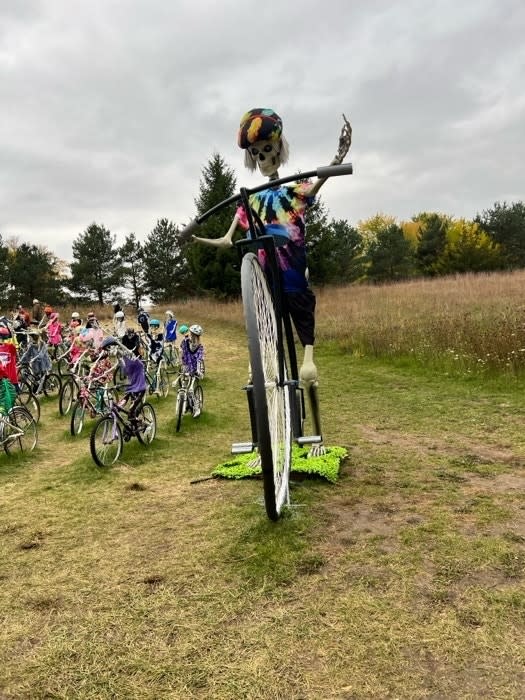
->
[193,109,352,455]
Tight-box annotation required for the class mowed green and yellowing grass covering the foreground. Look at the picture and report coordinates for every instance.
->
[0,317,525,700]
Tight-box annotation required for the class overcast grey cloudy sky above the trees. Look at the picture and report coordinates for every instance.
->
[0,0,525,259]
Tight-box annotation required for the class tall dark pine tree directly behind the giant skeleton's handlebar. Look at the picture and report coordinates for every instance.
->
[185,153,240,298]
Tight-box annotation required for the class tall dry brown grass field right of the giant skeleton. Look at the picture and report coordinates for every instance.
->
[318,271,525,374]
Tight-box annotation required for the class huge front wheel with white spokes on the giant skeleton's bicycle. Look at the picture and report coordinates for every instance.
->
[241,253,292,520]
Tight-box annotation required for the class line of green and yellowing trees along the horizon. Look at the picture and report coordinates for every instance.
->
[0,153,525,306]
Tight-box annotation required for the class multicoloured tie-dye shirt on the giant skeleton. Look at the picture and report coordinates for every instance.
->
[237,182,314,292]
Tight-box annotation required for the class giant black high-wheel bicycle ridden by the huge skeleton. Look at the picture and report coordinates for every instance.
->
[182,163,352,520]
